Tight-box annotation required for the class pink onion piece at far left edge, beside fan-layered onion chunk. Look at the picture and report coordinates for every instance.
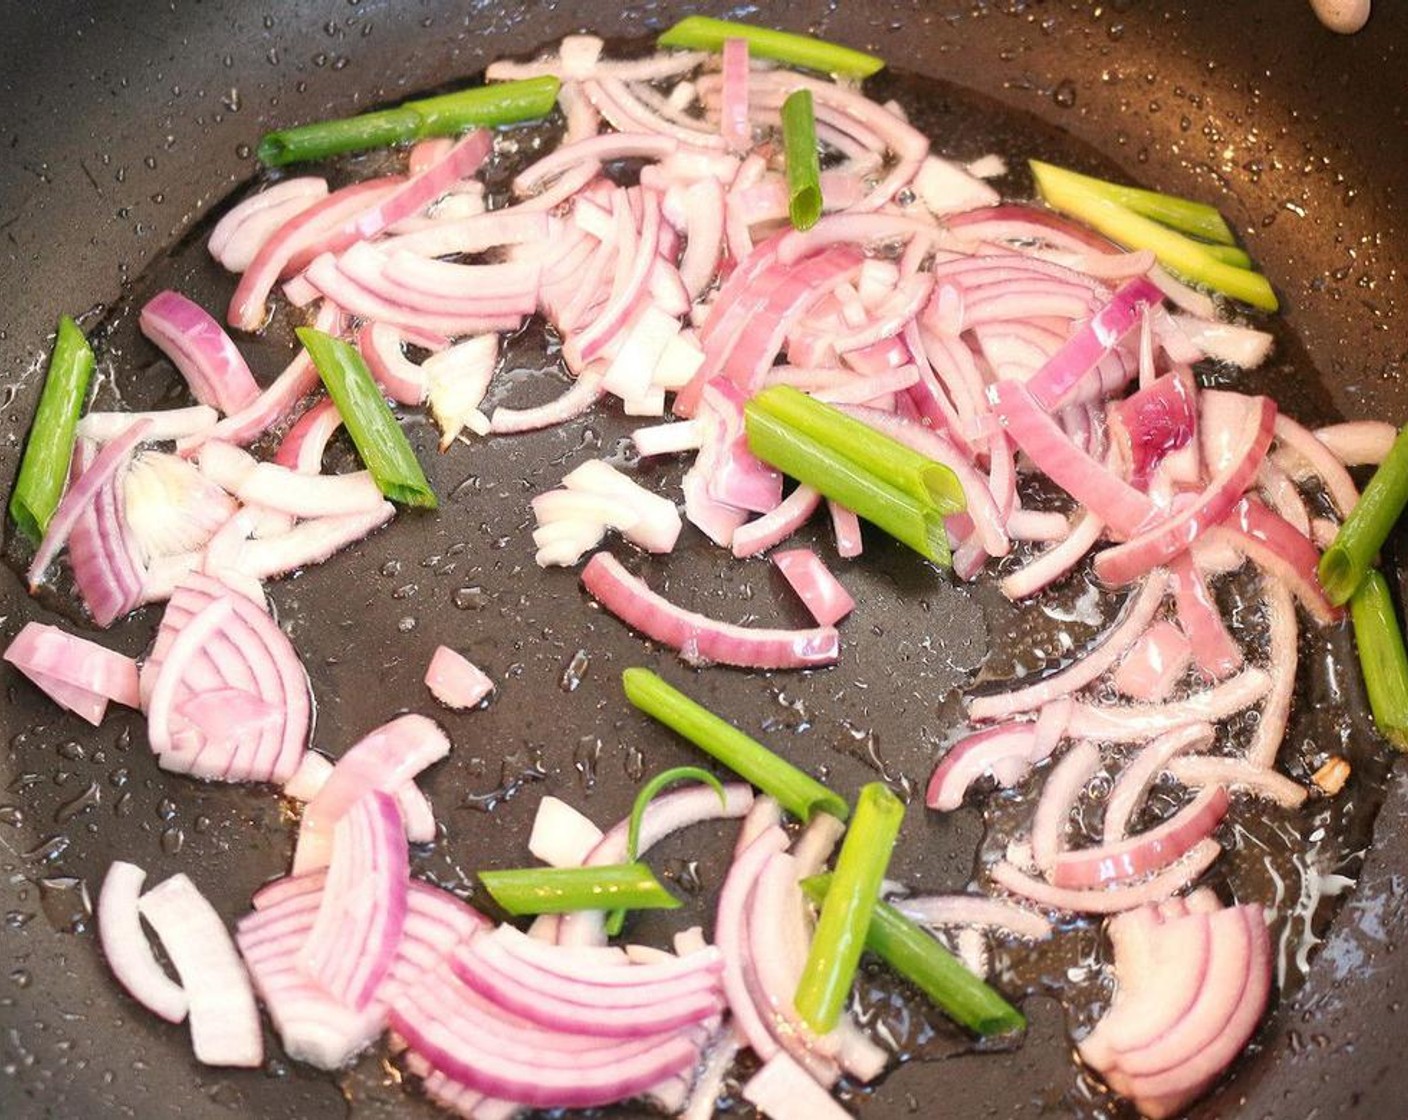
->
[4,623,139,727]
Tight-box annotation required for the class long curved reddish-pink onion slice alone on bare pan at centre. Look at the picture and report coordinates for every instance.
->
[582,552,839,669]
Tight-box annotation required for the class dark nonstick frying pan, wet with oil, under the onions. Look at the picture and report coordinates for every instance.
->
[0,0,1408,1117]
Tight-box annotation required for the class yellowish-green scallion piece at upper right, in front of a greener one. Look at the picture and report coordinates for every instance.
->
[1032,159,1280,311]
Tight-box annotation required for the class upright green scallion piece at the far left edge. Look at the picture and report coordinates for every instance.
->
[10,316,94,542]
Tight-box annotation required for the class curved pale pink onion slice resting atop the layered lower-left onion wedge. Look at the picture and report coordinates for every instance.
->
[293,716,449,875]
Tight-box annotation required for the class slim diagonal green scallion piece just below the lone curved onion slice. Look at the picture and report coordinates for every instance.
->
[621,668,850,821]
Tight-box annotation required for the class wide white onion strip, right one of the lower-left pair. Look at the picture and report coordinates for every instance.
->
[138,875,263,1068]
